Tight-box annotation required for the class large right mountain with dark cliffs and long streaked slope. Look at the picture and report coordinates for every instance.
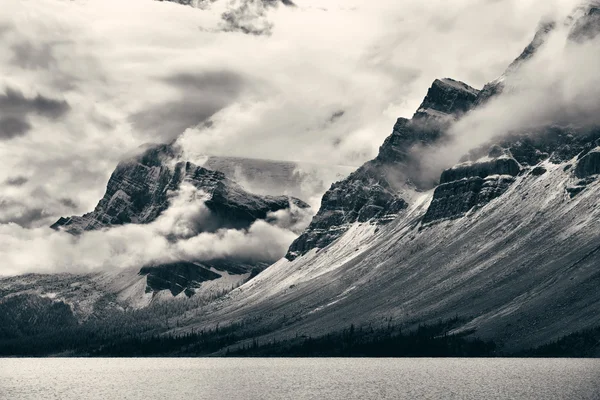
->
[159,6,600,354]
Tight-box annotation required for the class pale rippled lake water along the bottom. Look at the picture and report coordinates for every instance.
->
[0,358,600,400]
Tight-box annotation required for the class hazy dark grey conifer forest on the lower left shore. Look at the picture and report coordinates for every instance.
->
[0,295,216,356]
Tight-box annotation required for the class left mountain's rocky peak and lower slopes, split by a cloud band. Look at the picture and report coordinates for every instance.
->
[0,145,309,319]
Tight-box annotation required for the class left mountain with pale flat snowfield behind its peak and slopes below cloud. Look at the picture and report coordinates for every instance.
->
[0,145,351,321]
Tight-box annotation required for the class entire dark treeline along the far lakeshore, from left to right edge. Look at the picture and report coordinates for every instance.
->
[0,295,600,357]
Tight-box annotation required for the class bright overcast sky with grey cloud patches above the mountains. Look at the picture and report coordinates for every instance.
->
[0,0,576,274]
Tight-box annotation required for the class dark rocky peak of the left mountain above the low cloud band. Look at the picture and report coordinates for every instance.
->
[52,145,308,234]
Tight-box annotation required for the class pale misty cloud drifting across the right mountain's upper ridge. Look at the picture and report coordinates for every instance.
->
[420,7,600,176]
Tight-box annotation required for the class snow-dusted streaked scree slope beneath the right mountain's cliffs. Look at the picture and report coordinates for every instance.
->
[173,159,600,349]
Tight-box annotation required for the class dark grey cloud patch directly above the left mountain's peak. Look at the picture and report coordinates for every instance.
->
[131,71,244,141]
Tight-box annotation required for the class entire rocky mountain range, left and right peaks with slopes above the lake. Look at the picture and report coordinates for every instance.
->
[0,0,600,356]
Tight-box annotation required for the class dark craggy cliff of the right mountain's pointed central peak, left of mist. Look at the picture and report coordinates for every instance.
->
[286,79,478,260]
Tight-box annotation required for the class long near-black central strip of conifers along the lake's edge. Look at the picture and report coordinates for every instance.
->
[75,318,496,357]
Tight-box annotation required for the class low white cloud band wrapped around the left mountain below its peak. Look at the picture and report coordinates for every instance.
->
[0,185,310,275]
